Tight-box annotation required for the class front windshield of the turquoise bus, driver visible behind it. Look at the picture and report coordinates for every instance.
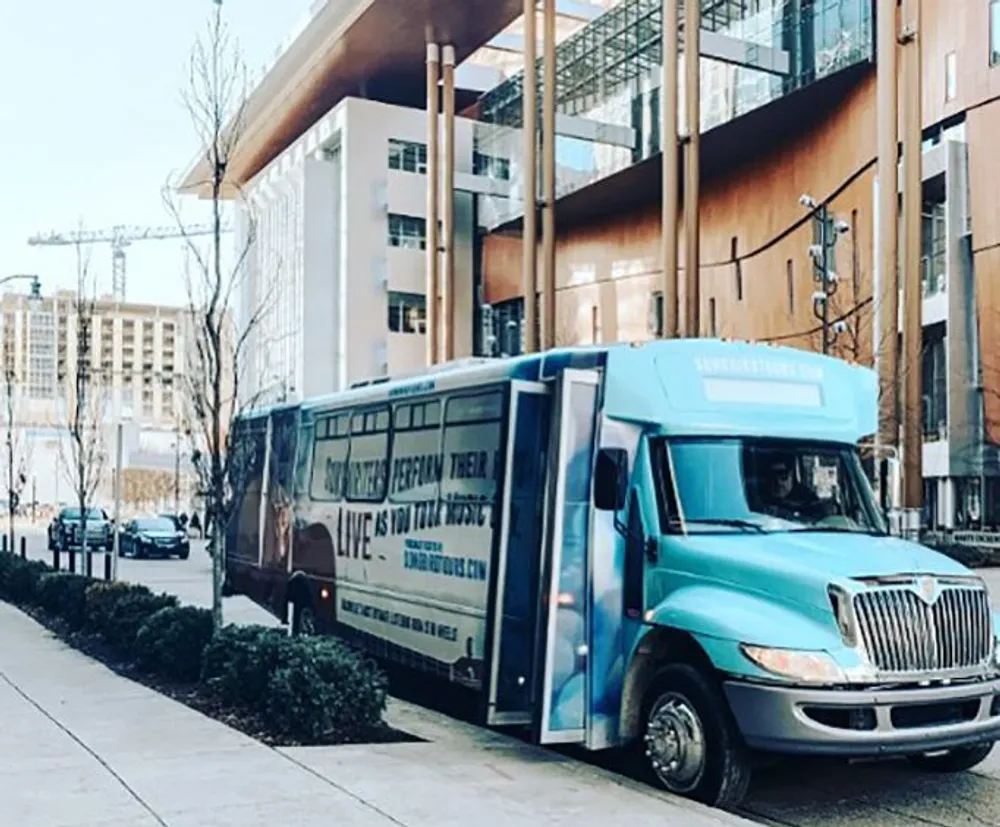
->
[660,437,885,534]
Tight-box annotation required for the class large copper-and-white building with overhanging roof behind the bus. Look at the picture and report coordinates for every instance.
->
[184,0,1000,527]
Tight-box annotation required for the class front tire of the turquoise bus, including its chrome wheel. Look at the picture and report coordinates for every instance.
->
[639,663,751,810]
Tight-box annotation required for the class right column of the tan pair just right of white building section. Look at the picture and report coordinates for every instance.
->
[542,0,556,350]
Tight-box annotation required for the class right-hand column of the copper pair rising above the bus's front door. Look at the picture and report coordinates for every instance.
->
[684,0,701,337]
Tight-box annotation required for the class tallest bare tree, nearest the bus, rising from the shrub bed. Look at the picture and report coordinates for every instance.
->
[164,0,277,627]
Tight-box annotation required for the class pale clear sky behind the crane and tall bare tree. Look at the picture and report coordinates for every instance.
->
[0,0,311,304]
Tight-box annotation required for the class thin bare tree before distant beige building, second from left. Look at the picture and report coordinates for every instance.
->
[58,245,107,573]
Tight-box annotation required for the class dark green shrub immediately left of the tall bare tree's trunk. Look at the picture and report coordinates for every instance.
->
[135,606,212,682]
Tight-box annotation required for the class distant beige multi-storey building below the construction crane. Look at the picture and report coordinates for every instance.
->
[0,291,190,505]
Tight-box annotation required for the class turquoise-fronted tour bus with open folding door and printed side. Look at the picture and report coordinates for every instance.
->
[226,339,1000,807]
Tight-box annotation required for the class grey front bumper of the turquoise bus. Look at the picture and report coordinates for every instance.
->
[723,679,1000,757]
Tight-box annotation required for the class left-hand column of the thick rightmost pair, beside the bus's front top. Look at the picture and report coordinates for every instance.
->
[875,0,899,446]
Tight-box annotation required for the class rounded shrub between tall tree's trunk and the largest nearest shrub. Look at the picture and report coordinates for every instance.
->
[201,626,288,709]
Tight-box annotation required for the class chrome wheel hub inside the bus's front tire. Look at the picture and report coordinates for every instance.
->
[645,692,706,793]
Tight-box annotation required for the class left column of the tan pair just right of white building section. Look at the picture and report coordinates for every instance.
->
[521,0,539,353]
